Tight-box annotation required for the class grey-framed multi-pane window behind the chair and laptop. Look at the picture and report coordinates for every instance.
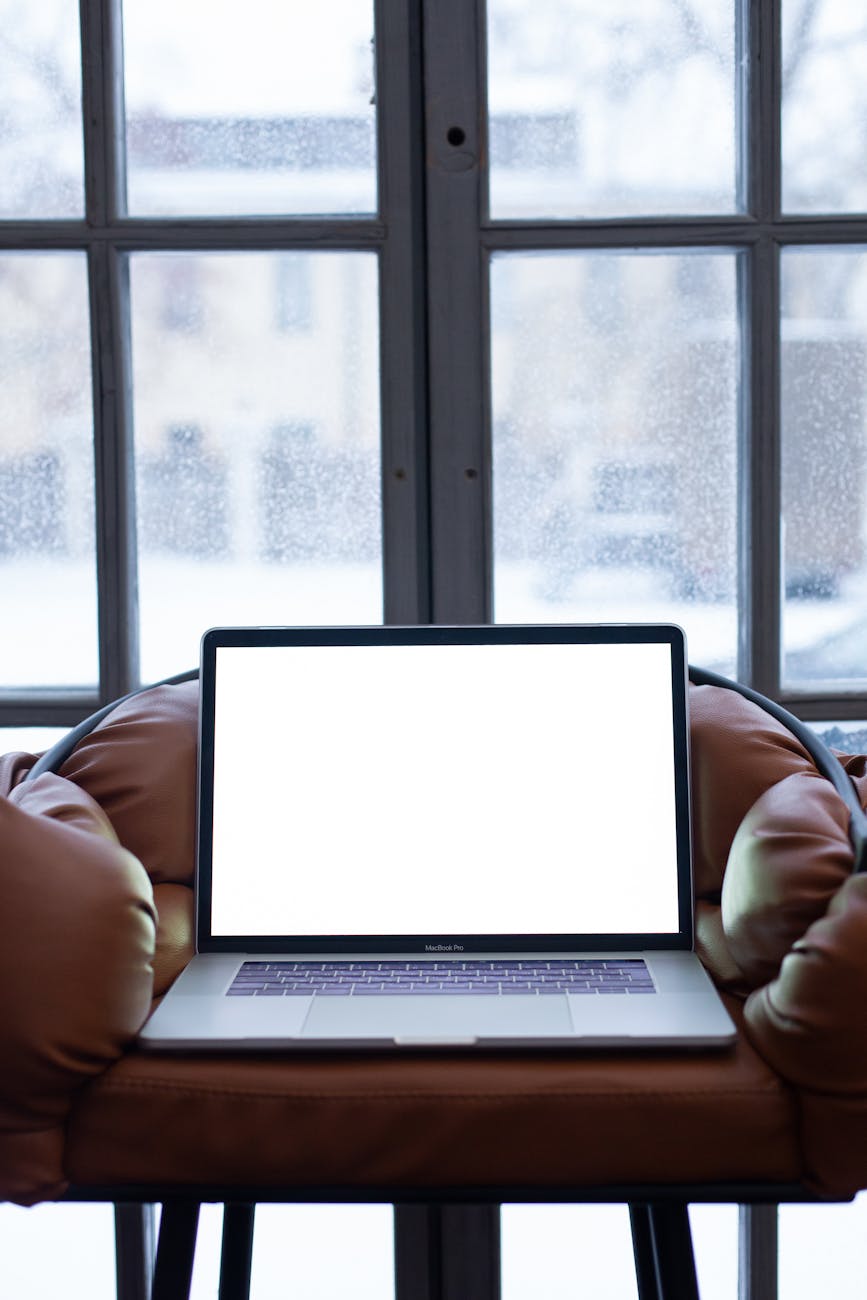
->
[0,0,867,1294]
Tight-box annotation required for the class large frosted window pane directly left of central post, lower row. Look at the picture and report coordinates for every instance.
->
[131,252,382,680]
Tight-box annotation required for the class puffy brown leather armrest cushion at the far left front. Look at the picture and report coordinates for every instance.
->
[0,774,156,1204]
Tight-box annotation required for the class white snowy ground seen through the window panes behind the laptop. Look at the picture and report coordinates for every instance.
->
[0,558,867,686]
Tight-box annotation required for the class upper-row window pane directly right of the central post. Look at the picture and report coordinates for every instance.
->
[487,0,738,217]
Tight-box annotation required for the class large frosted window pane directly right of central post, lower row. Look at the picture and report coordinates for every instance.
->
[491,252,740,672]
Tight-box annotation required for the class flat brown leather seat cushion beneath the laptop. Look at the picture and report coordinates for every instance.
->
[66,1002,801,1191]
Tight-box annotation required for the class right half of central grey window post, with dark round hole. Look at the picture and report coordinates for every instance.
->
[424,0,491,623]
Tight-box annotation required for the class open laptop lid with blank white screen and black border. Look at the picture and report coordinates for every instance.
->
[196,624,693,954]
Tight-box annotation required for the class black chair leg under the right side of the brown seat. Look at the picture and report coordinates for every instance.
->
[629,1201,699,1300]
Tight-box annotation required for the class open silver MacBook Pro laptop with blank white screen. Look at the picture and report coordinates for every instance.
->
[140,624,736,1052]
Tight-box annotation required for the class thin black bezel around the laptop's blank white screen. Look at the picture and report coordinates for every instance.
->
[195,624,693,957]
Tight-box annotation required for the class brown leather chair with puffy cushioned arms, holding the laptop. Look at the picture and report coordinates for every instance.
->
[0,677,867,1300]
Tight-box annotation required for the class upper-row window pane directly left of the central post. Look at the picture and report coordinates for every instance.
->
[123,0,377,216]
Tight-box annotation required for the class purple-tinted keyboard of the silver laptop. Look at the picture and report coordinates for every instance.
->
[226,958,656,997]
